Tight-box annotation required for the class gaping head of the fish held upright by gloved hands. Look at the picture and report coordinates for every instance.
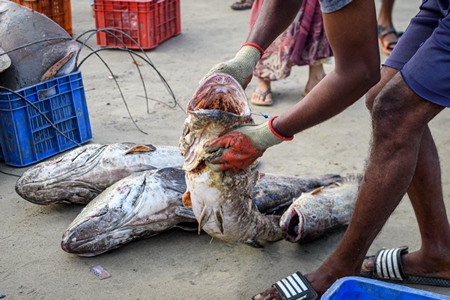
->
[179,73,254,171]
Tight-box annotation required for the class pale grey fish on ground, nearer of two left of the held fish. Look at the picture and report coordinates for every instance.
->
[61,168,197,256]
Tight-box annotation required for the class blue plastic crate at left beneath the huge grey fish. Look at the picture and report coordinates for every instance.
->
[0,71,92,167]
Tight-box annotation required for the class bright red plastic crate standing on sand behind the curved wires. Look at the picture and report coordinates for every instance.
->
[94,0,181,50]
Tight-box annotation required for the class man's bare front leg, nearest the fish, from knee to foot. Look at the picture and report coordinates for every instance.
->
[306,73,444,294]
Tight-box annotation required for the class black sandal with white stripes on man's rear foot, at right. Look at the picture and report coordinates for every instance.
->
[361,246,450,287]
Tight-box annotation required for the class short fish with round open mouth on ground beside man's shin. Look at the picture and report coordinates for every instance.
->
[280,175,362,243]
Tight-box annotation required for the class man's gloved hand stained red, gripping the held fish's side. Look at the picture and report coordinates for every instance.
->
[204,117,294,173]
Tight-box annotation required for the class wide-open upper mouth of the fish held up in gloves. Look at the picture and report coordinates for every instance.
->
[187,73,251,116]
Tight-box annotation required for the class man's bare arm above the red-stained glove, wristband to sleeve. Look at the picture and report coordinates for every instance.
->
[273,0,380,137]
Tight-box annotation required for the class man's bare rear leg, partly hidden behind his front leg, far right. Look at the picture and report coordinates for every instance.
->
[363,67,450,278]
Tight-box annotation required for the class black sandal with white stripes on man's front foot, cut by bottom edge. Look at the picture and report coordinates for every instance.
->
[252,272,317,300]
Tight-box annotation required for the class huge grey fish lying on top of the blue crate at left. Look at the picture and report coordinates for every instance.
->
[0,0,79,90]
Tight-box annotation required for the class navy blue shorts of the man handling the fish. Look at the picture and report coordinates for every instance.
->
[384,0,450,107]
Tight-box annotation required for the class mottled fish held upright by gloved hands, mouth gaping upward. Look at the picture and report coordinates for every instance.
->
[179,73,282,247]
